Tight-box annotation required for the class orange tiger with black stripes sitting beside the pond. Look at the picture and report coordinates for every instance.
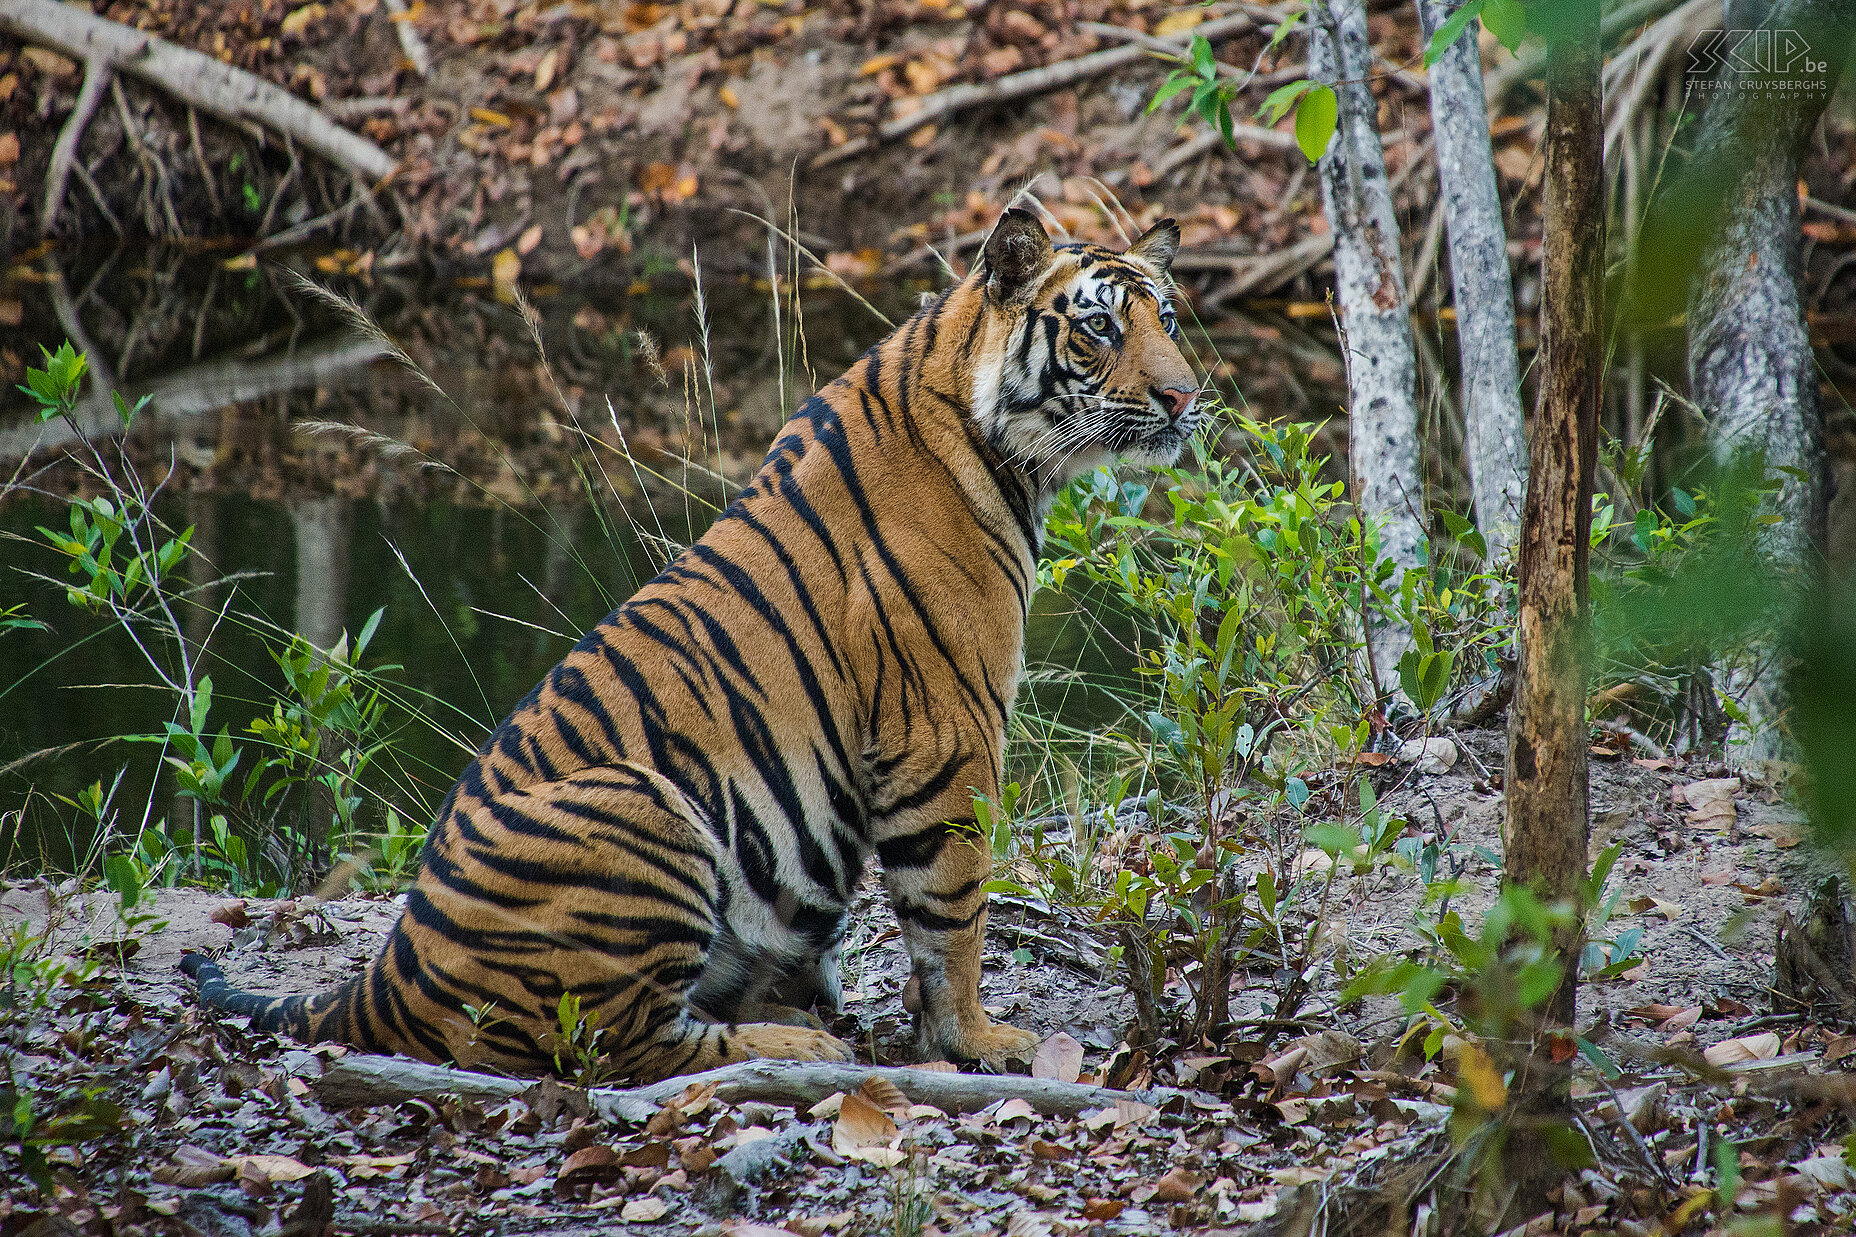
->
[182,208,1203,1081]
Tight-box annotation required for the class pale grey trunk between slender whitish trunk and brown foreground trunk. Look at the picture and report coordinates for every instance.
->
[1418,0,1527,563]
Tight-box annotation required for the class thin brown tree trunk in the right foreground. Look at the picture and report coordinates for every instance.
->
[1502,0,1605,1203]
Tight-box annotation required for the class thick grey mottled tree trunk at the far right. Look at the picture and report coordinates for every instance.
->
[1689,0,1850,773]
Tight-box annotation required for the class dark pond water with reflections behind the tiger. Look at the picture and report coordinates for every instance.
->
[0,245,1187,869]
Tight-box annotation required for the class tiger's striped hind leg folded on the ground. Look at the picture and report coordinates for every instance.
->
[401,767,852,1079]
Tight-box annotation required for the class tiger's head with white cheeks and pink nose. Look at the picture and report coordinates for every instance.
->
[969,208,1201,494]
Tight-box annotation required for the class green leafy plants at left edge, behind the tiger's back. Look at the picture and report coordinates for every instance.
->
[0,344,425,895]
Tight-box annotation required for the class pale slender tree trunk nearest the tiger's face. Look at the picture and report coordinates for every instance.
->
[1308,0,1425,691]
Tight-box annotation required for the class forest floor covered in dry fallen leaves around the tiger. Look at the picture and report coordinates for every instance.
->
[0,732,1856,1237]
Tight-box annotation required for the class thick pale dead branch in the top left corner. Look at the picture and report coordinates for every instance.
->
[0,0,397,180]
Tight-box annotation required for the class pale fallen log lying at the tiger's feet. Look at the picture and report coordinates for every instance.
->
[314,1053,1182,1124]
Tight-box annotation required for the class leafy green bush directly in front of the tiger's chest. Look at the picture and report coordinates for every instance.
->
[982,408,1505,1042]
